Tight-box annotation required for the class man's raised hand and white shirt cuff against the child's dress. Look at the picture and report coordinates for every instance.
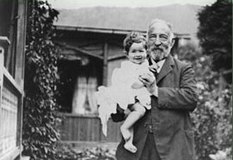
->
[138,73,158,97]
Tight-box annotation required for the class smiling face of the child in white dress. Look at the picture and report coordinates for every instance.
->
[128,43,147,64]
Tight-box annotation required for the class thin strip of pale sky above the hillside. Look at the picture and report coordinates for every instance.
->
[48,0,216,9]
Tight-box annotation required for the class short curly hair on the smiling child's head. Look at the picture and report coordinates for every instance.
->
[123,32,147,54]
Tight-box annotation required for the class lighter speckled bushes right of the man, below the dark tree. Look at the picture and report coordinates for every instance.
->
[178,43,232,160]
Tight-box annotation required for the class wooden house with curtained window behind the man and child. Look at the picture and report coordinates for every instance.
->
[55,25,189,146]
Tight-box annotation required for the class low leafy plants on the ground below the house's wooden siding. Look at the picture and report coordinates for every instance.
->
[56,145,115,160]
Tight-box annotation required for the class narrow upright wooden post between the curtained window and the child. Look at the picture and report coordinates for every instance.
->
[103,40,108,86]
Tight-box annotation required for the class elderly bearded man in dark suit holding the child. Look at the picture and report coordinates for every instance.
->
[116,19,197,160]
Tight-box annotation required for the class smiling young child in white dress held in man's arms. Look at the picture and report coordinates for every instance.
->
[97,32,152,153]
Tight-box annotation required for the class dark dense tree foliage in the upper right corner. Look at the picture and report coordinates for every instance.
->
[198,0,232,80]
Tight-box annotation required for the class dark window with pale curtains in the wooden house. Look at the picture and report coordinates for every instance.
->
[57,57,102,115]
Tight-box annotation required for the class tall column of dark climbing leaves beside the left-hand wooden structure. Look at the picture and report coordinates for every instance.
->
[23,0,59,160]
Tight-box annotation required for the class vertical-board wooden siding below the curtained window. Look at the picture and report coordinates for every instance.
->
[60,113,121,142]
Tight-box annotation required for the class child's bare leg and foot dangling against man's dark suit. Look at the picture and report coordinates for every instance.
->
[121,103,146,153]
